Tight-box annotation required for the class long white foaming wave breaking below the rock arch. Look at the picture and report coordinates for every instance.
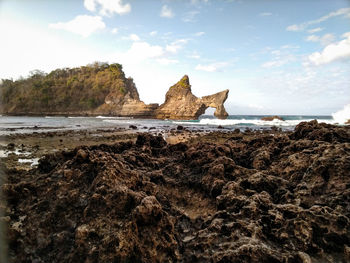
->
[174,119,335,126]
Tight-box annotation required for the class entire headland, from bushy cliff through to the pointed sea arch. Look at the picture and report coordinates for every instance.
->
[0,62,228,119]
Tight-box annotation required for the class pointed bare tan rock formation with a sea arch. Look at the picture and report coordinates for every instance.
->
[155,75,229,120]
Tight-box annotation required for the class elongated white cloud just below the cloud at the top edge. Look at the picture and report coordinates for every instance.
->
[49,15,106,37]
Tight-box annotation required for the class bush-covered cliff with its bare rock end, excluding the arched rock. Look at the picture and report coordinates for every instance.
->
[0,62,157,117]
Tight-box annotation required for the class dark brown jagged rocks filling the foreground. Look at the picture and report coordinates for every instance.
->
[1,121,350,263]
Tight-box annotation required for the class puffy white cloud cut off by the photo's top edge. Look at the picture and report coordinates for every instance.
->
[84,0,131,16]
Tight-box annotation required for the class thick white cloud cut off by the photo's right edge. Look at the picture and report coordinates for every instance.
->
[308,32,350,66]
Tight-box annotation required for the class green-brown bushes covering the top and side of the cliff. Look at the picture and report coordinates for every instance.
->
[0,62,128,114]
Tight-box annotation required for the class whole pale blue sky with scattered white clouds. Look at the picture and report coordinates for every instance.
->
[0,0,350,115]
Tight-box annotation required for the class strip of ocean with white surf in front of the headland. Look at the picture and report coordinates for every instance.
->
[0,115,338,135]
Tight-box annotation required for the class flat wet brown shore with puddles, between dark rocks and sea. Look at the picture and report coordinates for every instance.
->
[0,126,209,169]
